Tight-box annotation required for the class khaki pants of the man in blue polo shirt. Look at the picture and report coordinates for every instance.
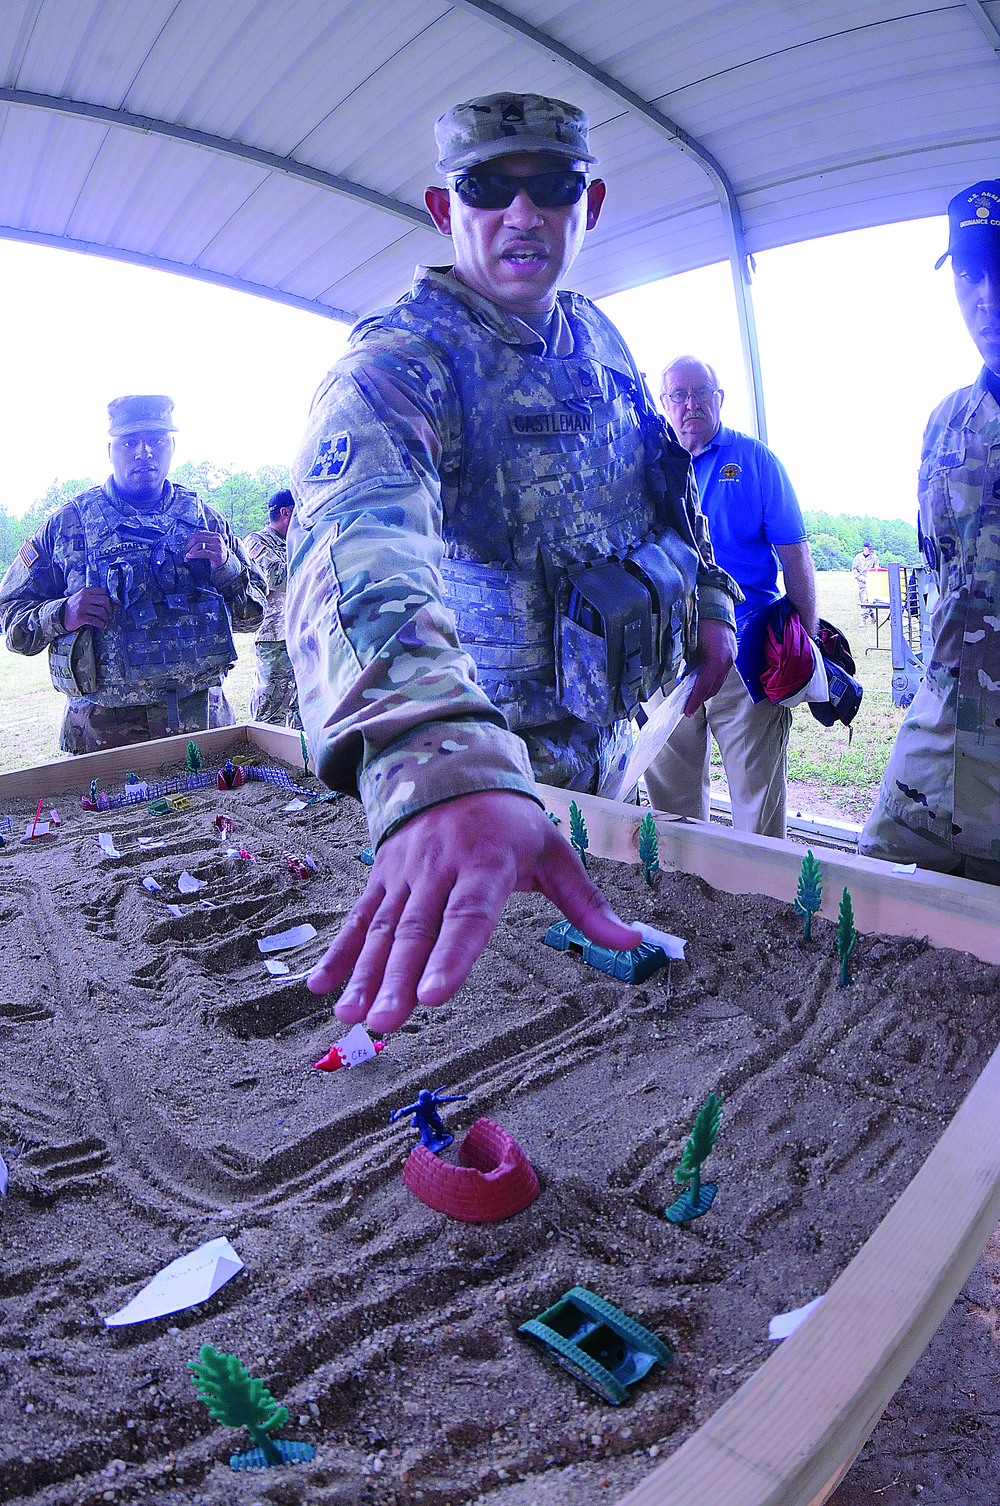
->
[646,669,792,837]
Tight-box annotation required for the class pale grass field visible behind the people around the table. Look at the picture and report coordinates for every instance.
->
[0,571,902,818]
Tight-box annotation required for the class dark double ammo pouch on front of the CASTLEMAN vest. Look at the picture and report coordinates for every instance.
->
[556,533,699,726]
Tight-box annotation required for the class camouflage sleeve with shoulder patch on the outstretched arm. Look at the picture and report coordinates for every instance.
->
[285,330,538,842]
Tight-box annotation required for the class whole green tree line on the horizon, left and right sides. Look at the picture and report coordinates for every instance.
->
[0,461,920,572]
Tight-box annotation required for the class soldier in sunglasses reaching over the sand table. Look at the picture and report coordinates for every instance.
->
[286,93,741,1029]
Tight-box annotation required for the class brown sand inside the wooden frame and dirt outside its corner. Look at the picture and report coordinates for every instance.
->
[0,743,1000,1506]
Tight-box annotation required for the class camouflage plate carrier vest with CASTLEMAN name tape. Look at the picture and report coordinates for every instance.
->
[357,283,702,730]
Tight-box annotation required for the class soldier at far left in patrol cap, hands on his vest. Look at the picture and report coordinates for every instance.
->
[0,395,265,753]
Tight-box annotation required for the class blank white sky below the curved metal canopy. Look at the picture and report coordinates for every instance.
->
[0,218,979,521]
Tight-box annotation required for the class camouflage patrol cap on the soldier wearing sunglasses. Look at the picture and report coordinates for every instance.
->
[434,93,596,173]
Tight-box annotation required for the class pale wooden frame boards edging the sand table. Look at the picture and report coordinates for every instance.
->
[0,723,1000,1506]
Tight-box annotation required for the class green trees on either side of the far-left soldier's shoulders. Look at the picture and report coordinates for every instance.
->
[0,461,288,572]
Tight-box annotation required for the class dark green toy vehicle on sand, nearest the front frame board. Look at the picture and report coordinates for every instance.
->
[518,1286,673,1407]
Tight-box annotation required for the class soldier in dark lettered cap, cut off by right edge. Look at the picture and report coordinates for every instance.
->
[858,181,1000,884]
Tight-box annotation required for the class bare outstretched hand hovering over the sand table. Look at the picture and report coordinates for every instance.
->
[309,791,642,1030]
